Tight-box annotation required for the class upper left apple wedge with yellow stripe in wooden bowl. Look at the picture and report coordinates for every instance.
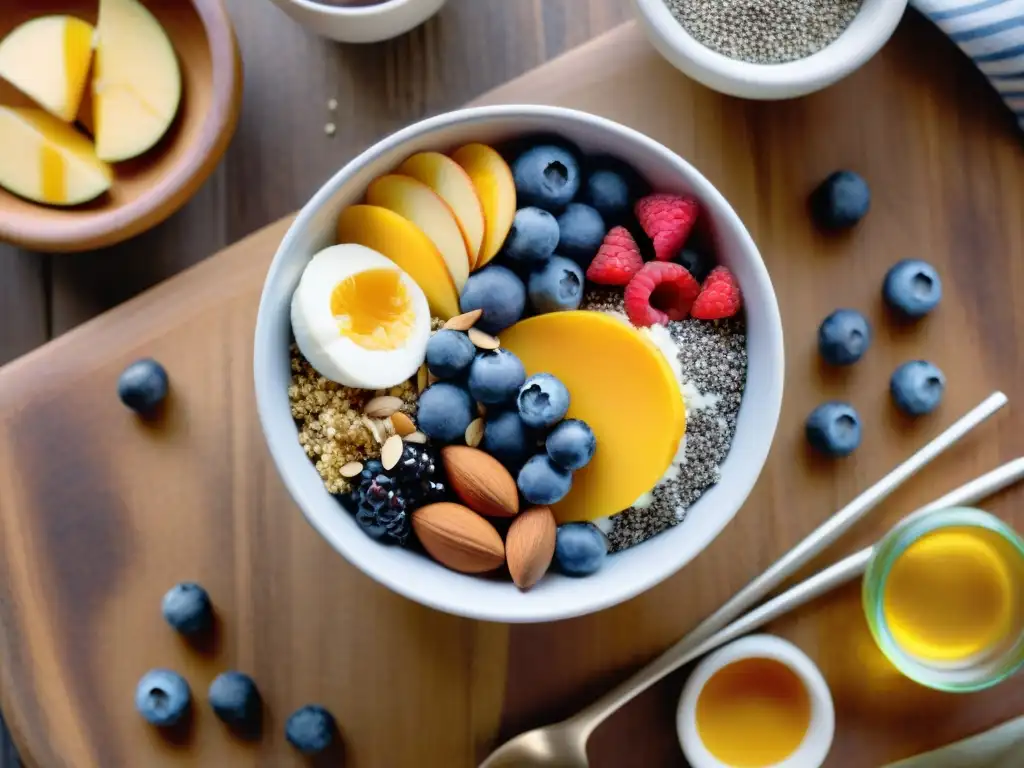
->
[0,15,93,123]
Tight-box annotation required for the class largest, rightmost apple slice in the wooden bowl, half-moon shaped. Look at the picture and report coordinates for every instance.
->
[92,0,181,163]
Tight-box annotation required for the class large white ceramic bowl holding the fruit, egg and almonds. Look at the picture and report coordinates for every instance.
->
[255,105,783,622]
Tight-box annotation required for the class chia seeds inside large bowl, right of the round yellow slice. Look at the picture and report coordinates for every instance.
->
[582,290,746,552]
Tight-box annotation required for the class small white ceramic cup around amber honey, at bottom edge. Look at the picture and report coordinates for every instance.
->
[676,635,836,768]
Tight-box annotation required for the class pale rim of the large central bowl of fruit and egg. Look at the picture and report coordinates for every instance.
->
[253,104,785,624]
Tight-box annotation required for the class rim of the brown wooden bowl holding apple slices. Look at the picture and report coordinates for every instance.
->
[0,0,243,253]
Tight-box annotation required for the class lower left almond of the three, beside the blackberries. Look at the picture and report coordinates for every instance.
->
[413,502,505,573]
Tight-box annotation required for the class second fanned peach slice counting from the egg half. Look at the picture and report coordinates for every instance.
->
[367,174,469,291]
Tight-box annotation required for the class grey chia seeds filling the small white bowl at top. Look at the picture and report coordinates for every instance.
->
[665,0,862,63]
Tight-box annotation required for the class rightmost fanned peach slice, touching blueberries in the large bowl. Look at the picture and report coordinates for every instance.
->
[452,144,516,269]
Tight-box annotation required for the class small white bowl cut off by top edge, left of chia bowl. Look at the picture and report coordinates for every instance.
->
[264,0,444,43]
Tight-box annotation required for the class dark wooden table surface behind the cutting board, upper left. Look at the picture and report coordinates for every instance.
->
[0,0,631,768]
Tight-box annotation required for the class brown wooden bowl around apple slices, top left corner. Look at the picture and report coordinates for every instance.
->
[0,0,242,252]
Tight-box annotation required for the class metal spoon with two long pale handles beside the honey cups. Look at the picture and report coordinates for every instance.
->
[480,392,1007,768]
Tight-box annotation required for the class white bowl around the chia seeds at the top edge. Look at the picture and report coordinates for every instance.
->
[633,0,906,99]
